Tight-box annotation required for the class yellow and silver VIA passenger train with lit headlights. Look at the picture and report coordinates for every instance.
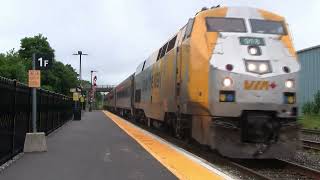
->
[105,7,300,159]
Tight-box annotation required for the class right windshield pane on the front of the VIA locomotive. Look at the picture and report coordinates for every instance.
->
[250,19,286,35]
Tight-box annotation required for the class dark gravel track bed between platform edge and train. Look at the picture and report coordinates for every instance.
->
[115,114,320,180]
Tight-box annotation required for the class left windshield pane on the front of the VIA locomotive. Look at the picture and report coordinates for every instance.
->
[206,17,247,32]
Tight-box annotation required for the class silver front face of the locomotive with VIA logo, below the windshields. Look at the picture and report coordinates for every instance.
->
[209,9,300,158]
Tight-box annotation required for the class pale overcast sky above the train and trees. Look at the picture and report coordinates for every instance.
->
[0,0,320,84]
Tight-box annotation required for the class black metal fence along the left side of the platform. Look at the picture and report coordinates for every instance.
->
[0,77,73,165]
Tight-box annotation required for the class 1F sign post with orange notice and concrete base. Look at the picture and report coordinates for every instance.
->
[24,53,51,152]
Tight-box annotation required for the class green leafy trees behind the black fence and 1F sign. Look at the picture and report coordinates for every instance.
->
[0,34,79,95]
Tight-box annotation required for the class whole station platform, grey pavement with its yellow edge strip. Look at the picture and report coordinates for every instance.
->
[0,111,231,180]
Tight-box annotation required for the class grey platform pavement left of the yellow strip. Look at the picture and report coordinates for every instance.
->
[0,111,177,180]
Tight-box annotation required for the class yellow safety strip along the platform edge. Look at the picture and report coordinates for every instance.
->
[103,111,223,180]
